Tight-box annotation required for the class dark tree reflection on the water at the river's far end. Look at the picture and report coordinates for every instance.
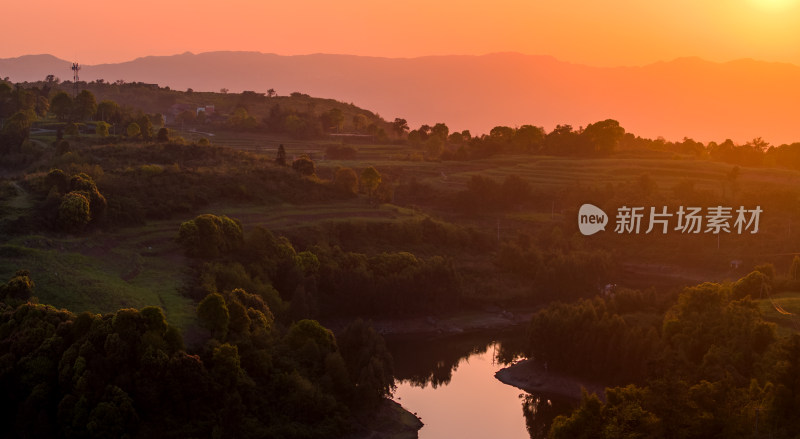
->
[388,334,525,389]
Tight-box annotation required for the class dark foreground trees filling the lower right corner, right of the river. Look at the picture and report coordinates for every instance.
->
[530,266,800,438]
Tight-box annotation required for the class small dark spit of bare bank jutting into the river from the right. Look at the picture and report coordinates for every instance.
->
[494,359,605,401]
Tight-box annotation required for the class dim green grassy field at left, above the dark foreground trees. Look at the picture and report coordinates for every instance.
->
[0,221,195,329]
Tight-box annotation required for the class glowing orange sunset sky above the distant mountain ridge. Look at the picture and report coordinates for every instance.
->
[0,0,800,66]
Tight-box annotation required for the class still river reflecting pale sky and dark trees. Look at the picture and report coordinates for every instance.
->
[387,331,574,439]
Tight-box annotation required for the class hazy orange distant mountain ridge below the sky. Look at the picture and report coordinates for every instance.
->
[0,52,800,144]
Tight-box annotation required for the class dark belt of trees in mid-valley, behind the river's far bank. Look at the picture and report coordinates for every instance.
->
[178,214,462,319]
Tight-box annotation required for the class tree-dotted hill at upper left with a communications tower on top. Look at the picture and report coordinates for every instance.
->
[0,74,392,140]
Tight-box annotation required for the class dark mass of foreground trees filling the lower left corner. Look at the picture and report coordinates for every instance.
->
[0,271,394,438]
